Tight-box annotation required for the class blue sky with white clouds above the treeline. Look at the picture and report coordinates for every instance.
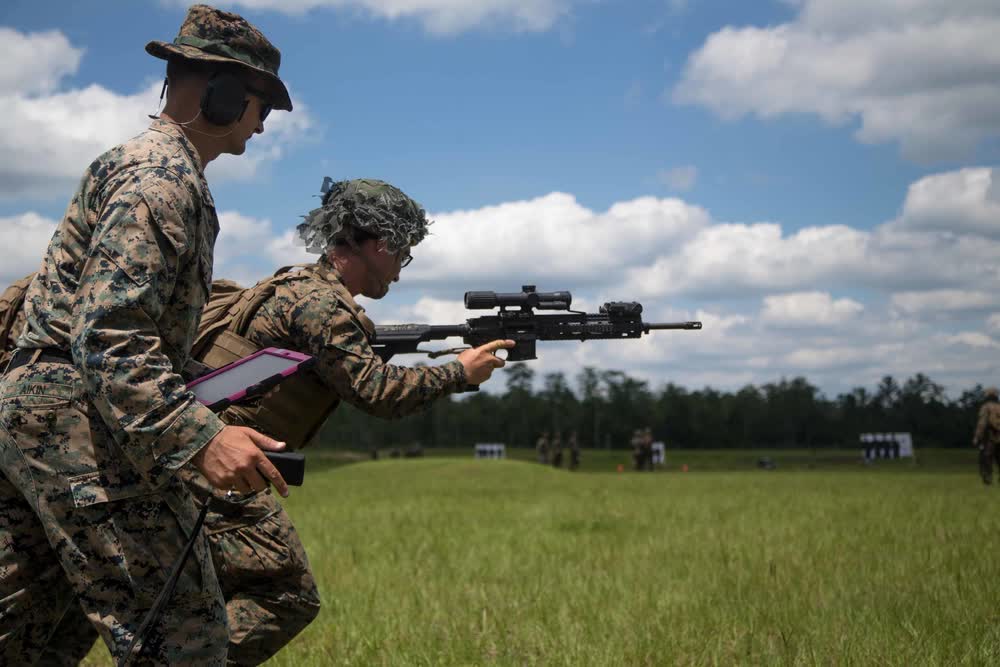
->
[0,0,1000,394]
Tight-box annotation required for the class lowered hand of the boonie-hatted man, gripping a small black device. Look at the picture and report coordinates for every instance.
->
[192,426,288,498]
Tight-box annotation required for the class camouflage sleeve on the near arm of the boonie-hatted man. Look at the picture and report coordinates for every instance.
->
[72,177,223,478]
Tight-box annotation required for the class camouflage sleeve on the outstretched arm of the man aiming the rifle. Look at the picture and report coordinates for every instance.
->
[270,290,466,419]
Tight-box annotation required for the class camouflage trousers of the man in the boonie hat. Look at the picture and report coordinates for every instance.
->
[0,363,229,665]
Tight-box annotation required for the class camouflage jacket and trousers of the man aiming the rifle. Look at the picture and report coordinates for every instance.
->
[174,260,466,664]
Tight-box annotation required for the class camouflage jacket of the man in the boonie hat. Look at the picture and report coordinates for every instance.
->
[18,120,223,486]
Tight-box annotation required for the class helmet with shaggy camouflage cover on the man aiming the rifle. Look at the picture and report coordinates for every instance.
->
[298,176,431,254]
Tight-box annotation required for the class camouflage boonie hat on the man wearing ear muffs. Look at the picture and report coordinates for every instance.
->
[146,5,292,111]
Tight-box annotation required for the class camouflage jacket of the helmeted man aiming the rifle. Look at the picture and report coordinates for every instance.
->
[214,260,466,447]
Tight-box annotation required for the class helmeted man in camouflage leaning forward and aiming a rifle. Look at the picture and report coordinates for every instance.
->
[158,179,516,664]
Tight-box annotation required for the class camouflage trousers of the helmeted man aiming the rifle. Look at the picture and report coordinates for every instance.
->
[33,456,320,665]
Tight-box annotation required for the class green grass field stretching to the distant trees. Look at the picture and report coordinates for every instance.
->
[88,451,1000,666]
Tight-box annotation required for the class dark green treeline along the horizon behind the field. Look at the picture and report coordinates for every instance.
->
[320,364,983,449]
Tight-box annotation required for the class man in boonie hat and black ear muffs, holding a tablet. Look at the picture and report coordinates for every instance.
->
[0,5,291,664]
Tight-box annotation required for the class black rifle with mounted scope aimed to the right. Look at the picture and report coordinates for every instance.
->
[372,285,701,361]
